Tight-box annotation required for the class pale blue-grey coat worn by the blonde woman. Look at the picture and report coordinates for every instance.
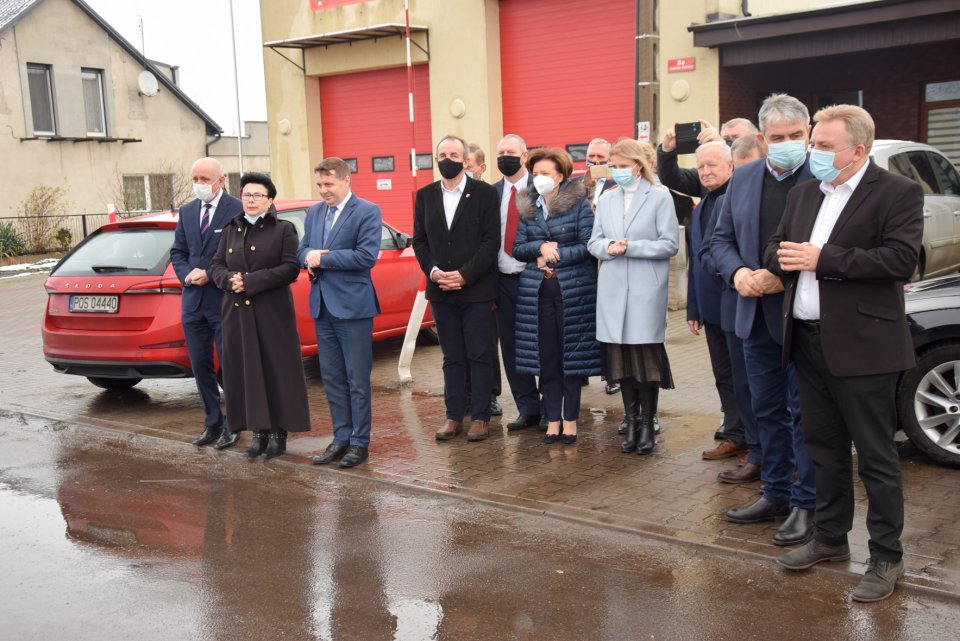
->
[587,178,680,345]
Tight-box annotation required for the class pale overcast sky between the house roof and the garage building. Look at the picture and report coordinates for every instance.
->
[86,0,267,134]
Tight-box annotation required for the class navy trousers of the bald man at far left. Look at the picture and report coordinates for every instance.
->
[181,307,227,427]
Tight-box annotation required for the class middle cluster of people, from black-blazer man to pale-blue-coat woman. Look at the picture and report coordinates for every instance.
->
[413,134,679,454]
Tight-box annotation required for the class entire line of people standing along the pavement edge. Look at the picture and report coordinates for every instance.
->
[171,89,923,601]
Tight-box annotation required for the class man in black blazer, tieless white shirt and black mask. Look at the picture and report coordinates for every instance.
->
[413,136,500,441]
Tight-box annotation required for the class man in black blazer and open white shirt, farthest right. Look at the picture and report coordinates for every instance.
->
[764,105,923,602]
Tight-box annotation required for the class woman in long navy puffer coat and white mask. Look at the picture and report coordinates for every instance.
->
[513,149,600,444]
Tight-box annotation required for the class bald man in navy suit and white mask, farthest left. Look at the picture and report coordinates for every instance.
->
[170,158,243,450]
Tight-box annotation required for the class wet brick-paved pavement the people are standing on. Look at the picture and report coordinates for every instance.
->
[0,276,960,596]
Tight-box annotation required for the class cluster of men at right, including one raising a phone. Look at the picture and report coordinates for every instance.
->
[658,94,923,602]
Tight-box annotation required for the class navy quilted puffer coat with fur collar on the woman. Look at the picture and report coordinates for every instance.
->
[513,181,600,376]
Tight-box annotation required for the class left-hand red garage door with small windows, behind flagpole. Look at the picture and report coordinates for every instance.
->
[320,65,433,233]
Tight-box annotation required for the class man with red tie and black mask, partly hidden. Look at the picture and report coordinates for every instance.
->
[493,134,540,431]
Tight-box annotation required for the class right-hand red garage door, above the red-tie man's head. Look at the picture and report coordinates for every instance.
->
[500,0,636,168]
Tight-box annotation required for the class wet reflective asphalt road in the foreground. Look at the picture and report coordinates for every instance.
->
[0,411,960,641]
